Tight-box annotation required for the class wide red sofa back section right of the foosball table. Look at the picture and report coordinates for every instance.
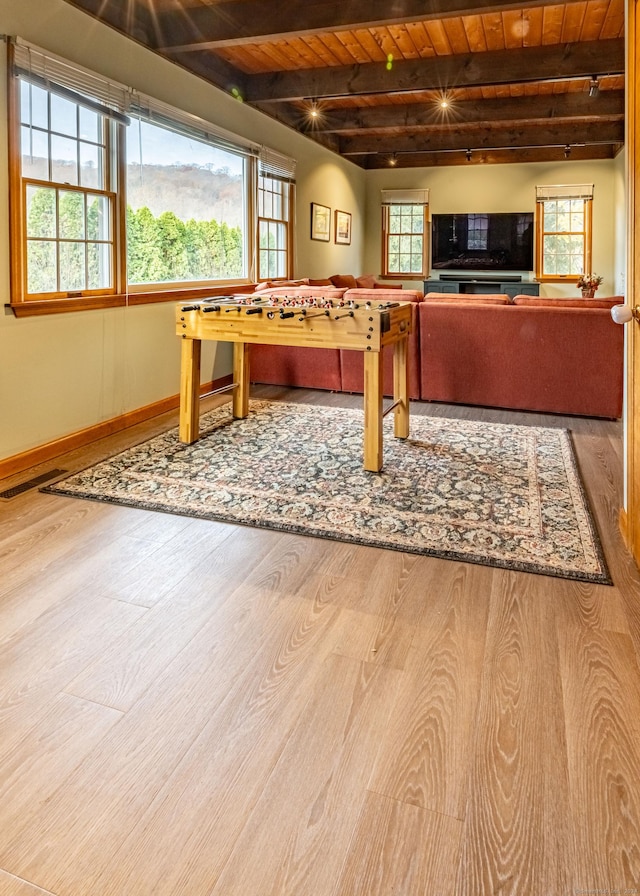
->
[418,295,624,418]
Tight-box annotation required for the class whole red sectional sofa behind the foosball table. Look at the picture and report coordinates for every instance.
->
[246,286,624,419]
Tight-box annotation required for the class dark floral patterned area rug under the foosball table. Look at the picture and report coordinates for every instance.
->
[42,401,611,584]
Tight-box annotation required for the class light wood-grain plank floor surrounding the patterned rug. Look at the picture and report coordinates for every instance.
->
[0,387,640,896]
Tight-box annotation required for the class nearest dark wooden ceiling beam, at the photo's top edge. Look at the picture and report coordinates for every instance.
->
[154,0,592,52]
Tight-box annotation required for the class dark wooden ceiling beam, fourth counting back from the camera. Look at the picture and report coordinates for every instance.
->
[340,121,624,156]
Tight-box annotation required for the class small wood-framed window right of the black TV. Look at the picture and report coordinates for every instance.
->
[536,184,593,282]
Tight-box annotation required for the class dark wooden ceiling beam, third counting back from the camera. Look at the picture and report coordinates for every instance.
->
[314,90,625,134]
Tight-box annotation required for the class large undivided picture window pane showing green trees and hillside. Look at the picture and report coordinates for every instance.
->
[127,119,248,287]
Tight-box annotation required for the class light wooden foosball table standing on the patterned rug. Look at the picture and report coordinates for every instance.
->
[176,295,411,473]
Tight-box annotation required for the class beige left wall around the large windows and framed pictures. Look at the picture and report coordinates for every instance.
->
[0,0,365,459]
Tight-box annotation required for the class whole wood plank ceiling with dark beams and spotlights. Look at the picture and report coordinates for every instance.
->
[61,0,625,168]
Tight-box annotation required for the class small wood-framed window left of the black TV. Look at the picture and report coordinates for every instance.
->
[382,190,430,278]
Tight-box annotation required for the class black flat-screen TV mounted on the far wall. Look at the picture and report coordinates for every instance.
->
[431,212,533,271]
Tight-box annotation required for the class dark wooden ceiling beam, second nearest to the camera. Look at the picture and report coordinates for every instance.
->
[245,38,625,103]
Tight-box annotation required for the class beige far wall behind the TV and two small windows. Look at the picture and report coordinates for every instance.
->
[365,158,625,296]
